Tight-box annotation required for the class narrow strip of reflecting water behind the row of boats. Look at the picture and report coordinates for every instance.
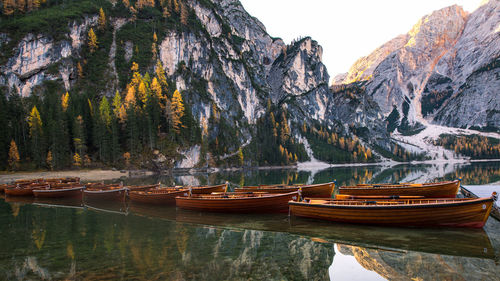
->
[110,162,500,187]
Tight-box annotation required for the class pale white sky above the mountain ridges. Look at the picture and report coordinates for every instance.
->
[240,0,481,81]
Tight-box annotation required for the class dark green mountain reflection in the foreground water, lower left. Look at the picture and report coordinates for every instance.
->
[0,198,333,280]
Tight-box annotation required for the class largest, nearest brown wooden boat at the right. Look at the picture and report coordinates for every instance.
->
[289,193,496,228]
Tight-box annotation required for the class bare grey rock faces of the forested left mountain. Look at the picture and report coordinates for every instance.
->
[0,0,344,167]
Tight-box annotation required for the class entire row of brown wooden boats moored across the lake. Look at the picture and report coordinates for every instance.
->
[0,177,497,228]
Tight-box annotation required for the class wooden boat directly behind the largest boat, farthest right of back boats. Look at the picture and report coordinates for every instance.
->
[338,180,460,198]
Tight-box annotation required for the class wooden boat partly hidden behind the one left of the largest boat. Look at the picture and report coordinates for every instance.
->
[234,182,335,197]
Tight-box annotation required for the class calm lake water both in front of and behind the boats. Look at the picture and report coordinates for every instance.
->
[0,162,500,281]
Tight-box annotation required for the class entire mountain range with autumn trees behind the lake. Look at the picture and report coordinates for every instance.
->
[0,0,500,170]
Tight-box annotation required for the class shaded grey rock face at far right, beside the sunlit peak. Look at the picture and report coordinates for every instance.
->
[423,0,500,128]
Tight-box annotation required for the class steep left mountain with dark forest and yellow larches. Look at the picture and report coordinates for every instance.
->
[0,0,375,169]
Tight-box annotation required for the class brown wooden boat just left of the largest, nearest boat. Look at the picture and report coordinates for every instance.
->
[175,191,298,213]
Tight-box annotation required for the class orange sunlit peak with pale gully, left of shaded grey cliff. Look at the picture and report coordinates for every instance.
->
[343,5,467,127]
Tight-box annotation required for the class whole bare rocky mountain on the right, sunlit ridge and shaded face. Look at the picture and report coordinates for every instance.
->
[336,0,500,131]
